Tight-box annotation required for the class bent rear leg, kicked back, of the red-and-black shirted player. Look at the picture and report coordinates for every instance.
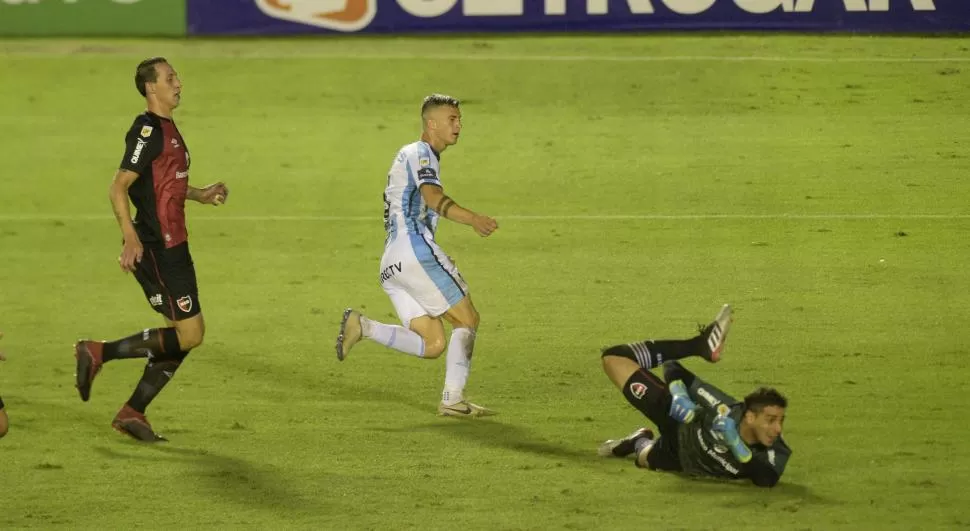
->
[74,245,181,402]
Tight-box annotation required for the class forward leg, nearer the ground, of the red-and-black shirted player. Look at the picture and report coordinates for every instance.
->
[112,244,205,442]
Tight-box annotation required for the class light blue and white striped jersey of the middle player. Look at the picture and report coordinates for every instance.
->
[384,141,441,242]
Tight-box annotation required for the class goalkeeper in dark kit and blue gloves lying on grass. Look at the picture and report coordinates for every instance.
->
[599,305,791,487]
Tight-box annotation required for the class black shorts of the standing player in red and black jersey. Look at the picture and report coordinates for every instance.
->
[135,242,202,321]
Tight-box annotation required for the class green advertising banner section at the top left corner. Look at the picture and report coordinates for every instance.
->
[0,0,185,37]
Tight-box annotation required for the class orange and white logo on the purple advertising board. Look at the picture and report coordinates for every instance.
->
[256,0,377,31]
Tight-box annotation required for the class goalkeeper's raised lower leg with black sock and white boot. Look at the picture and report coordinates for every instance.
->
[604,304,732,369]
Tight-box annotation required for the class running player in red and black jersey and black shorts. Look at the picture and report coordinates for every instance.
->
[74,57,229,442]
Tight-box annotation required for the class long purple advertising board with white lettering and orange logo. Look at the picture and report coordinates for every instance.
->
[187,0,970,35]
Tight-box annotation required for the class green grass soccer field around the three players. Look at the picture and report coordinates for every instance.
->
[0,35,970,530]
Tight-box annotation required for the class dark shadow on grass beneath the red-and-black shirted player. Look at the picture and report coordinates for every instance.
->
[95,441,323,513]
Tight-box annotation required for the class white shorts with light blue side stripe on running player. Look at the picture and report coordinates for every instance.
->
[380,232,468,328]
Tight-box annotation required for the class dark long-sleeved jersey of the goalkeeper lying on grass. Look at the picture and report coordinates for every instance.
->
[667,364,791,486]
